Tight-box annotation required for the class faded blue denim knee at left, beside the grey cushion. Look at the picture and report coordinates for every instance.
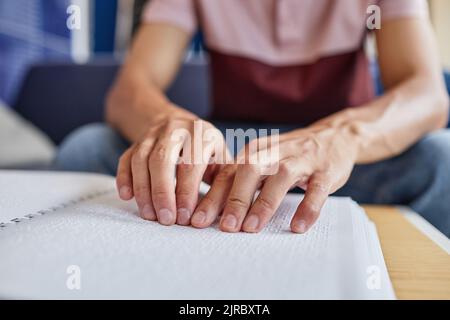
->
[54,124,128,175]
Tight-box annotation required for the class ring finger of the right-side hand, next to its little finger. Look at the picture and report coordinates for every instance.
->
[242,162,296,233]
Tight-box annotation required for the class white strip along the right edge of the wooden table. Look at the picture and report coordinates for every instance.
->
[397,206,450,255]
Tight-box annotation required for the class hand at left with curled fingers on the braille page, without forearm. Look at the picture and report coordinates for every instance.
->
[117,115,229,225]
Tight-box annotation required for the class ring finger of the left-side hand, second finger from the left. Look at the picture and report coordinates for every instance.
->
[131,139,156,221]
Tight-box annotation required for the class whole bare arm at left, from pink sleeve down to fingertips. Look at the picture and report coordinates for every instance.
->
[107,24,226,225]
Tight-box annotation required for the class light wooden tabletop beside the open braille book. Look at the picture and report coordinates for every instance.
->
[364,206,450,299]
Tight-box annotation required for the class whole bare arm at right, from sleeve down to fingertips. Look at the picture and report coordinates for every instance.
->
[193,19,448,233]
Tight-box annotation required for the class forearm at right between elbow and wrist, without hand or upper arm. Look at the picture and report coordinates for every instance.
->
[313,76,448,164]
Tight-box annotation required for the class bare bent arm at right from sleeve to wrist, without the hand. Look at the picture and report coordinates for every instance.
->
[319,19,448,163]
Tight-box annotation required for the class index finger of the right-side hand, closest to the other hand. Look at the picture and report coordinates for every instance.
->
[191,165,236,228]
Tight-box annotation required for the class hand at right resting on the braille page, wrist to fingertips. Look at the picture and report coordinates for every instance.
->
[192,125,358,233]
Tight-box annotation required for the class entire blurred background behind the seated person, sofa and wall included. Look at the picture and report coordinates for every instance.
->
[0,0,450,168]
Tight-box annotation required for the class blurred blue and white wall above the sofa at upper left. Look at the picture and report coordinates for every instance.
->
[0,0,204,103]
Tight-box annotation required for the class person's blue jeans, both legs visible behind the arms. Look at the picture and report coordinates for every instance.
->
[55,123,450,237]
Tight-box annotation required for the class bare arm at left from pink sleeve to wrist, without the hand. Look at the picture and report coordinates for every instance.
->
[106,24,198,142]
